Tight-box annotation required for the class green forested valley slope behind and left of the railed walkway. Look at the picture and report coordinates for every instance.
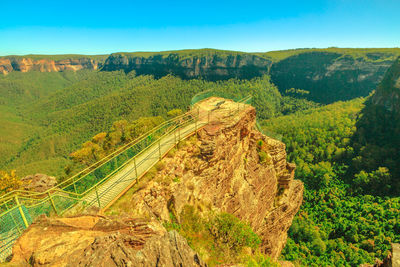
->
[0,71,300,180]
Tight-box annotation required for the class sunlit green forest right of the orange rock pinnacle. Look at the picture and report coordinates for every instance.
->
[263,99,400,266]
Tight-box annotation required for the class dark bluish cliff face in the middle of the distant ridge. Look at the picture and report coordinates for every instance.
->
[102,50,271,81]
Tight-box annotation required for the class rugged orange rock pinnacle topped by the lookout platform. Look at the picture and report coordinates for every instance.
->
[126,98,303,259]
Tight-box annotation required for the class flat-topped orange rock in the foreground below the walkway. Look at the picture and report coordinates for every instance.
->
[11,215,206,267]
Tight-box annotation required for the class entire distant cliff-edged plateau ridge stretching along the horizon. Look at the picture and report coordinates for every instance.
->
[0,48,400,103]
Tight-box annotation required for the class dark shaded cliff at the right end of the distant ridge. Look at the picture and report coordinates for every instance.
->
[270,52,393,103]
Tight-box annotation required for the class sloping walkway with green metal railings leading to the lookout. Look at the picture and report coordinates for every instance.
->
[0,92,251,262]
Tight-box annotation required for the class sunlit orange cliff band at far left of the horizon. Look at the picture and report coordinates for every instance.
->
[0,57,99,74]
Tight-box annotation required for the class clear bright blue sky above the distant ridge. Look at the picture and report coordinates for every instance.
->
[0,0,400,55]
